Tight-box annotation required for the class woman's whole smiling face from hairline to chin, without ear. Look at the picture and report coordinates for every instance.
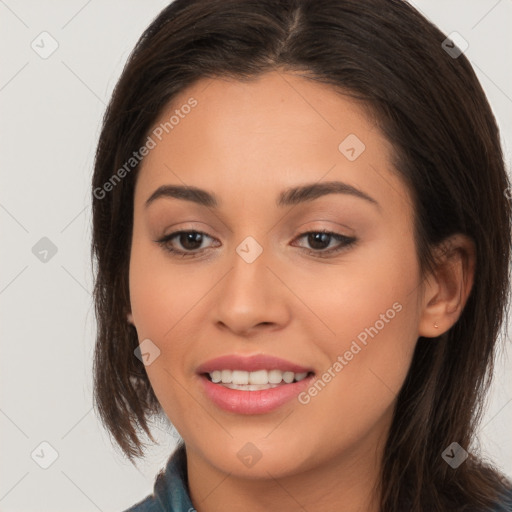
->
[130,72,422,484]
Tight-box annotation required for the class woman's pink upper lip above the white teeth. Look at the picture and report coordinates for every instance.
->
[197,354,313,373]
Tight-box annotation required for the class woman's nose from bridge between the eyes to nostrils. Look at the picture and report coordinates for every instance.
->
[213,237,290,337]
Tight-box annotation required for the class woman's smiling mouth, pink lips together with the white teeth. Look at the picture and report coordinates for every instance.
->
[197,354,315,414]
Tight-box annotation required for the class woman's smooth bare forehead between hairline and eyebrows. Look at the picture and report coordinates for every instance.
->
[133,72,407,218]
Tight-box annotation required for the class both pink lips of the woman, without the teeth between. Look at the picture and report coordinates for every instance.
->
[197,354,315,414]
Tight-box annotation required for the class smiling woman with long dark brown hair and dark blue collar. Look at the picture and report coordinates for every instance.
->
[93,0,512,512]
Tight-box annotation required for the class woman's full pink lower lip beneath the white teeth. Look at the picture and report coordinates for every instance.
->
[200,375,314,414]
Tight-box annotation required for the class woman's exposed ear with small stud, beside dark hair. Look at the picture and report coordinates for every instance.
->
[418,233,476,338]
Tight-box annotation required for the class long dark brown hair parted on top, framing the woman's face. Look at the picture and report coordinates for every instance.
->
[92,0,511,512]
